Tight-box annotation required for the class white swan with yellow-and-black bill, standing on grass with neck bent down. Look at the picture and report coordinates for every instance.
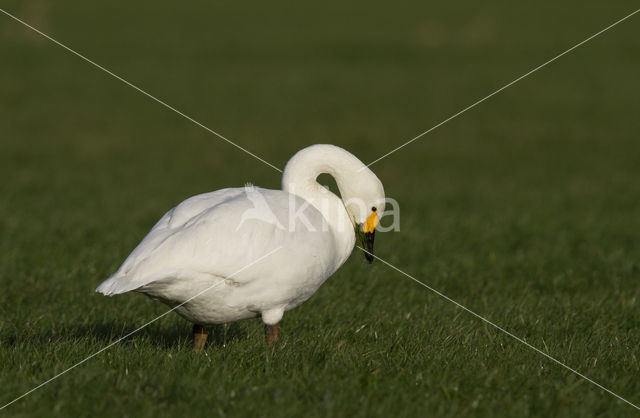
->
[96,145,385,350]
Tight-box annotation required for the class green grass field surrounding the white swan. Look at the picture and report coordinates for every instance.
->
[0,0,640,417]
